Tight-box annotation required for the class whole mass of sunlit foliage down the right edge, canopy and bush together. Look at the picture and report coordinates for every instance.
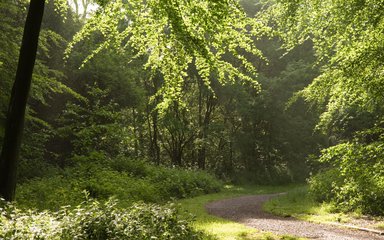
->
[260,0,384,215]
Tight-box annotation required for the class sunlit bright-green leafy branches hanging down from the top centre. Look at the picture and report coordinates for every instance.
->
[66,0,269,107]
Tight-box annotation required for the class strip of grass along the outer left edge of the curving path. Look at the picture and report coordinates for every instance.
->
[178,185,306,240]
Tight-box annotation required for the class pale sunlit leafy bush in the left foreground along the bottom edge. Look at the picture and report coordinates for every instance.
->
[0,200,202,240]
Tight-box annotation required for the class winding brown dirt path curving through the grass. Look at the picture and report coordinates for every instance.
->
[206,194,384,240]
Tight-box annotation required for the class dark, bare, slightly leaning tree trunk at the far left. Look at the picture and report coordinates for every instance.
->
[0,0,45,201]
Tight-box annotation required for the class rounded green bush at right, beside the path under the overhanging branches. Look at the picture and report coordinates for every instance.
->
[310,141,384,215]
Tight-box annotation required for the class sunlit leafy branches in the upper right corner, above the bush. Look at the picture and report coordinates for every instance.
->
[264,0,384,131]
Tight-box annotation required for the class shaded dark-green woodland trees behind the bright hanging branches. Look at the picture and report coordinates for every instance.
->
[2,0,321,190]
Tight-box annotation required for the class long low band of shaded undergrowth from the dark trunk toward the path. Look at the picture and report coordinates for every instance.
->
[16,154,221,210]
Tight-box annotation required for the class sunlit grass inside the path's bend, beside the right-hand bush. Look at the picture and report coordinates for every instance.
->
[263,185,384,228]
